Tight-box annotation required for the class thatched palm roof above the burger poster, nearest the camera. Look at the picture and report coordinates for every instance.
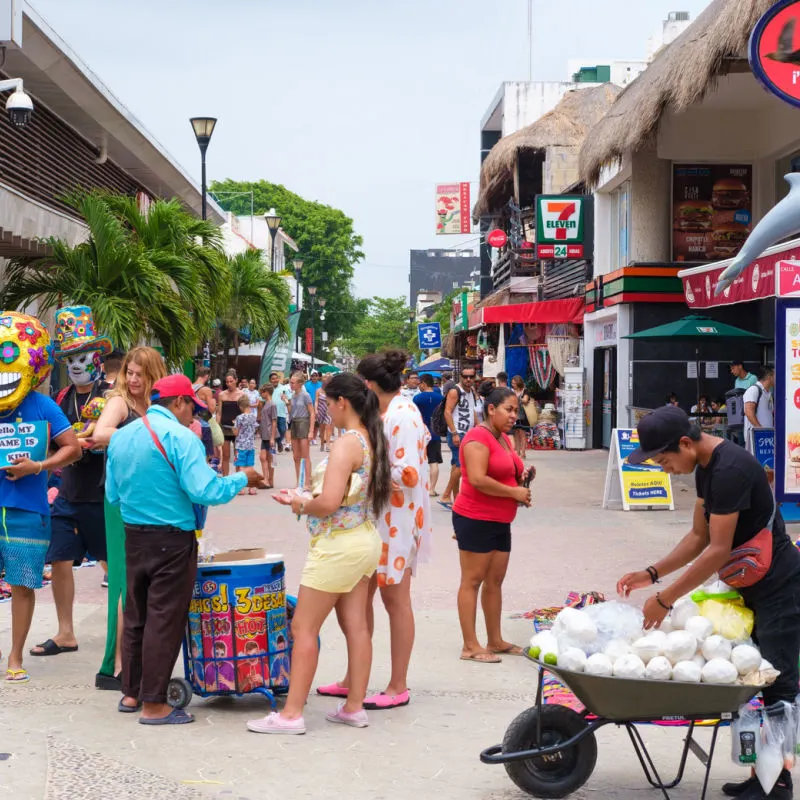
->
[580,0,775,185]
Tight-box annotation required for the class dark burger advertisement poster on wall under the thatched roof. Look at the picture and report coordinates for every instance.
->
[672,164,753,261]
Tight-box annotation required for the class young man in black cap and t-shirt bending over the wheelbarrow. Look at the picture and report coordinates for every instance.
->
[617,406,800,800]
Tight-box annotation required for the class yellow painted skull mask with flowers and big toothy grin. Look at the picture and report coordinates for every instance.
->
[0,311,53,412]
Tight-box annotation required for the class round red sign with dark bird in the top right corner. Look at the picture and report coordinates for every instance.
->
[748,0,800,107]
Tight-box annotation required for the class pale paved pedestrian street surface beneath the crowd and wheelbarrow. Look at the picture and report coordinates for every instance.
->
[0,452,764,800]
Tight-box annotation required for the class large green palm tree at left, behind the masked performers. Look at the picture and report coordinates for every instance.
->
[0,193,229,365]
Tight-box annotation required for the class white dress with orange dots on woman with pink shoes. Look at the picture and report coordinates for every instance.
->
[378,395,431,586]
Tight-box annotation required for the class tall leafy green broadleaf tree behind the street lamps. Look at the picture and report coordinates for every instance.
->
[211,180,364,352]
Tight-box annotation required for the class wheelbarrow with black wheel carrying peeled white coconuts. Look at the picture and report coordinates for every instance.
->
[480,658,763,800]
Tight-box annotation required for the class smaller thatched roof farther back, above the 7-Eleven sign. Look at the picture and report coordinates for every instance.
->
[473,83,622,220]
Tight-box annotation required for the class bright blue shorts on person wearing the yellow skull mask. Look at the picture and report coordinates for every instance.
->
[0,508,50,589]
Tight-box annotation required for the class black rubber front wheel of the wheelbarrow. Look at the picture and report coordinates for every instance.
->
[503,705,597,797]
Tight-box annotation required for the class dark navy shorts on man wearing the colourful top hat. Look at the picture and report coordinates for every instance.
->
[46,496,108,565]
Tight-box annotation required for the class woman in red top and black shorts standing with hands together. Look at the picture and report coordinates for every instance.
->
[453,383,536,664]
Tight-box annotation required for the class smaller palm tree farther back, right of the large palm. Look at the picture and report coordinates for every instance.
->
[220,250,291,368]
